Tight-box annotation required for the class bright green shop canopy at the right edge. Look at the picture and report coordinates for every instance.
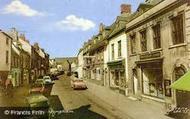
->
[170,71,190,91]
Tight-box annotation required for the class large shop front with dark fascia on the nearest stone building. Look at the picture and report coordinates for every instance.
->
[137,59,164,99]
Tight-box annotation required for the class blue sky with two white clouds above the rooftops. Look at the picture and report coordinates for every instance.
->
[0,0,144,58]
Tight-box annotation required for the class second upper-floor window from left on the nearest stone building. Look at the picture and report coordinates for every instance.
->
[140,30,147,52]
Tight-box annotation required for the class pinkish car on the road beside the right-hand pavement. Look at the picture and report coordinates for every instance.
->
[71,79,87,89]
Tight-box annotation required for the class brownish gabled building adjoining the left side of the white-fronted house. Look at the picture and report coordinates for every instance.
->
[88,23,109,85]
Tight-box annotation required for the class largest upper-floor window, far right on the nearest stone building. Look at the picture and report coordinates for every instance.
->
[171,14,184,45]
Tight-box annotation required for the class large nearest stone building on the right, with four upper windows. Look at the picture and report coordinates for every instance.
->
[126,0,190,107]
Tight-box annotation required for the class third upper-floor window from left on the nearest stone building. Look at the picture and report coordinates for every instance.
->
[152,24,161,49]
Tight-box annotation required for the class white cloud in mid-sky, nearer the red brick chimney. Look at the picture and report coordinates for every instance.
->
[56,15,95,31]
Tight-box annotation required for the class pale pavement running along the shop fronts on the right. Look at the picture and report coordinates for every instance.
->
[86,80,173,119]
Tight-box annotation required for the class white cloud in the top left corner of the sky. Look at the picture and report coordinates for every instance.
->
[3,0,44,17]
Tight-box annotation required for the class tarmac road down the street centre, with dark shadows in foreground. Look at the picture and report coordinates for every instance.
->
[51,75,131,119]
